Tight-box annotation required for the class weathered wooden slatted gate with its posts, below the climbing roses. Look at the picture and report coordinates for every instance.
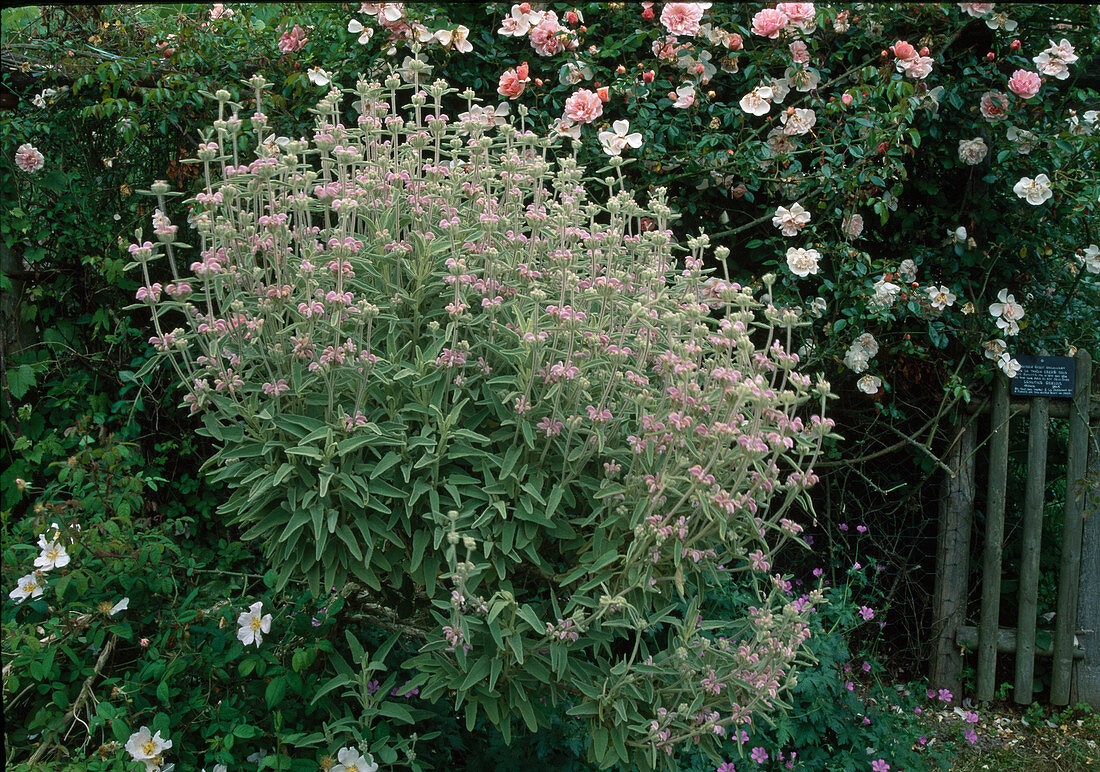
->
[931,351,1100,708]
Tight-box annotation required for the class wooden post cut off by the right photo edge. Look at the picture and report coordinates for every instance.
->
[1070,384,1100,708]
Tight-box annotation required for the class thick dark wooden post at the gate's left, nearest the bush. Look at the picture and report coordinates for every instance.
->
[932,420,977,704]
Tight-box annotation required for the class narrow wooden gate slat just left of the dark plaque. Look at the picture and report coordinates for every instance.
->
[977,374,1015,701]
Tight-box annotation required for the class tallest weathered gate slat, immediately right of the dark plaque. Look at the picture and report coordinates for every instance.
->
[1051,350,1092,705]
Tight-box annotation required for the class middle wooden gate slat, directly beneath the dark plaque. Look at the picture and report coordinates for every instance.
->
[1012,397,1051,705]
